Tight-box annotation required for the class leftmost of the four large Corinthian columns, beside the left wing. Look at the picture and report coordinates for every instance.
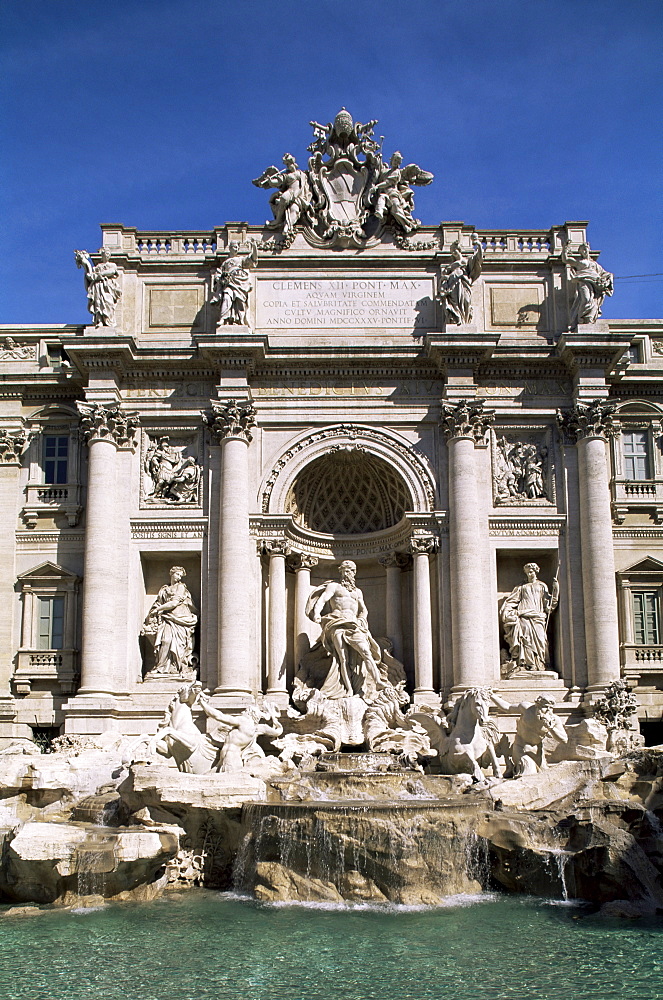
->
[77,403,138,695]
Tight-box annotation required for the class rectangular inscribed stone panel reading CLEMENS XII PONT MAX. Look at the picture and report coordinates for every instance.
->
[256,276,435,330]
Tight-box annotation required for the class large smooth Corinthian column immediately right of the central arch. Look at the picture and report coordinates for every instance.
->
[441,400,494,689]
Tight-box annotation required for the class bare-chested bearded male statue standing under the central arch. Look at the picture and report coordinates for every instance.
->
[306,559,384,700]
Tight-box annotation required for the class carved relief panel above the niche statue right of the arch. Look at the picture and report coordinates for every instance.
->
[490,427,556,507]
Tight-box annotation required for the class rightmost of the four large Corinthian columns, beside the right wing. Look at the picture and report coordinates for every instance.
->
[557,400,620,690]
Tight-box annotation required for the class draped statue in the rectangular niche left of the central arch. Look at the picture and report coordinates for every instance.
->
[141,566,198,678]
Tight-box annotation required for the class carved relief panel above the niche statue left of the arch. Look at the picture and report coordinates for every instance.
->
[140,428,203,508]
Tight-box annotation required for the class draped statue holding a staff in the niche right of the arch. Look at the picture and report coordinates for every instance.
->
[500,563,559,670]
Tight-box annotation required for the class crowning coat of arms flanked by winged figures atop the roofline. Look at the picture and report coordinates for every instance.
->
[253,108,433,246]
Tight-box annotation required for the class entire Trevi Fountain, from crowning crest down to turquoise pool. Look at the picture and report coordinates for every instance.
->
[0,109,663,1000]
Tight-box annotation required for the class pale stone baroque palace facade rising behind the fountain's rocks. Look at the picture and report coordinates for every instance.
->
[0,111,663,739]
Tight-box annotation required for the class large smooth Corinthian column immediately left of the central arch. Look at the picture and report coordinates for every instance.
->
[207,399,256,701]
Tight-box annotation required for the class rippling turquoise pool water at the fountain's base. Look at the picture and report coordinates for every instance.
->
[0,890,663,1000]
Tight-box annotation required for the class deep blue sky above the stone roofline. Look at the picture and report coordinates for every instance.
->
[0,0,663,323]
